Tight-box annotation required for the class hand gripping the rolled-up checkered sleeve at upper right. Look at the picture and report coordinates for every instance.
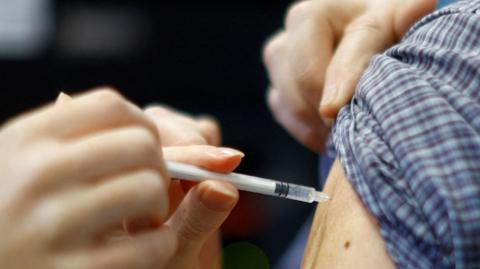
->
[263,0,436,152]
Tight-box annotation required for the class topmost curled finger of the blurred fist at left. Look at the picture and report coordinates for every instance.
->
[26,89,159,140]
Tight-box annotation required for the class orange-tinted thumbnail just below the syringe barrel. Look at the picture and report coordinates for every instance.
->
[199,181,238,212]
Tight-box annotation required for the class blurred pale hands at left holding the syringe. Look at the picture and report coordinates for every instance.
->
[0,89,243,269]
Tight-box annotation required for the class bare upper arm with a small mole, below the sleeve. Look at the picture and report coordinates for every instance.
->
[302,160,395,269]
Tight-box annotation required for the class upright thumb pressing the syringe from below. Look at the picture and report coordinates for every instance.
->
[167,181,239,268]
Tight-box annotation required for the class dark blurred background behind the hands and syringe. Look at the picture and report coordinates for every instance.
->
[0,0,317,265]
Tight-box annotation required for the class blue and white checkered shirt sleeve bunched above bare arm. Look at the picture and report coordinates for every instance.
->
[332,0,480,268]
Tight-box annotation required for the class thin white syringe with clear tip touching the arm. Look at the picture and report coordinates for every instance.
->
[166,161,330,203]
